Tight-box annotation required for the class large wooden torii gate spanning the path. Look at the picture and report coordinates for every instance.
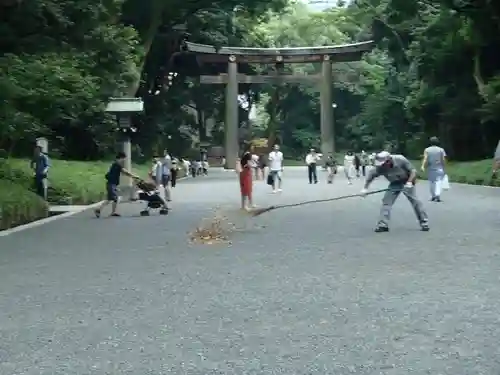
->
[186,41,374,169]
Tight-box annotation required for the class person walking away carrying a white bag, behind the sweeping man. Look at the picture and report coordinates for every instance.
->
[420,137,446,202]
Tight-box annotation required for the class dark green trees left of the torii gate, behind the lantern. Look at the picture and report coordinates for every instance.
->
[0,0,283,159]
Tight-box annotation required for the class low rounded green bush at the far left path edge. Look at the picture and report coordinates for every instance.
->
[0,179,49,230]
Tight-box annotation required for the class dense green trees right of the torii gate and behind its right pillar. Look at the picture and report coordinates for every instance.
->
[249,0,500,160]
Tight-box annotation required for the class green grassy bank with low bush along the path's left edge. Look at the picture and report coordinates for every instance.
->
[0,159,184,230]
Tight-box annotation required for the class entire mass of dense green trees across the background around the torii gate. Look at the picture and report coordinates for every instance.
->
[0,0,500,159]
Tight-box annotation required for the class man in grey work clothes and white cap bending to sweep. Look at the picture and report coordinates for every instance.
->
[361,151,429,232]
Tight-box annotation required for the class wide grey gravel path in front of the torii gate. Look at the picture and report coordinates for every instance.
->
[0,168,500,375]
